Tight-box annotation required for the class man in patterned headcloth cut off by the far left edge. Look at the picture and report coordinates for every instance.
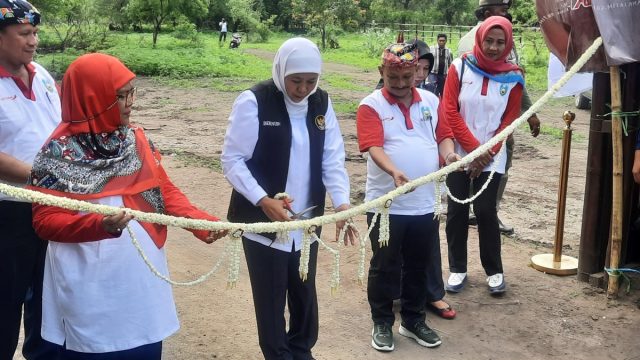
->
[0,0,60,360]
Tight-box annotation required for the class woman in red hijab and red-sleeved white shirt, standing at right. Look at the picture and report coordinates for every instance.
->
[442,16,524,294]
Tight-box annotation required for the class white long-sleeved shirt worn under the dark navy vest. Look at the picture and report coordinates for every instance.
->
[221,90,349,252]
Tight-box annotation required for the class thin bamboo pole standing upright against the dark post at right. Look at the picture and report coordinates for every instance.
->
[607,66,623,298]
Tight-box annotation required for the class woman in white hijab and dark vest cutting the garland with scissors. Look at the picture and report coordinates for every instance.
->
[221,38,355,360]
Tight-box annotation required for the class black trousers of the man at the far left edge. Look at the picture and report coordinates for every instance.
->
[0,201,57,360]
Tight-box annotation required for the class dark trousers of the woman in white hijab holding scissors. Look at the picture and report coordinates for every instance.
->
[242,238,319,360]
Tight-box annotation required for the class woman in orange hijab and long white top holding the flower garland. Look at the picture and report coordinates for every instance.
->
[31,54,224,359]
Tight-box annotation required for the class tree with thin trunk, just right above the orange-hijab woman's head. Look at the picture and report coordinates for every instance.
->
[126,0,208,48]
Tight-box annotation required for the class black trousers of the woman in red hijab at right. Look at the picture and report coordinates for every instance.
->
[446,172,503,276]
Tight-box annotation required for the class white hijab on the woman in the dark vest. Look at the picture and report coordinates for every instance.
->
[271,37,322,117]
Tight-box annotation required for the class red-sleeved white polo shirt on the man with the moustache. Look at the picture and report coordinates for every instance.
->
[357,88,447,215]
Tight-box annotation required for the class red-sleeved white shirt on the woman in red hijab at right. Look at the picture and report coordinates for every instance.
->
[442,58,522,174]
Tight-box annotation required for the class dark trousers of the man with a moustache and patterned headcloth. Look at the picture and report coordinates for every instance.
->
[367,213,442,326]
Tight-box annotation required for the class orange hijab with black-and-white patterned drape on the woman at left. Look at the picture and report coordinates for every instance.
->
[30,54,167,248]
